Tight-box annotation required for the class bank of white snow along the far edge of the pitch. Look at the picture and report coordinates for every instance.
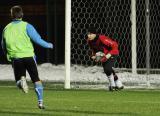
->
[0,63,160,87]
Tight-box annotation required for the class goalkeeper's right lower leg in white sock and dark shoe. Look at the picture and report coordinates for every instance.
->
[113,70,124,90]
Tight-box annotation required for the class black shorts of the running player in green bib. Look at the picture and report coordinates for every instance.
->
[12,57,40,83]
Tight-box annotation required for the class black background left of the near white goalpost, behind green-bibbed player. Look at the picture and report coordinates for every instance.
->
[0,0,65,64]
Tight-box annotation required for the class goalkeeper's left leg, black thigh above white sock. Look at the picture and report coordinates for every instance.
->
[102,59,115,91]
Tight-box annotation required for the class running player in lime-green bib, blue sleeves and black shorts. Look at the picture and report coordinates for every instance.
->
[2,6,53,109]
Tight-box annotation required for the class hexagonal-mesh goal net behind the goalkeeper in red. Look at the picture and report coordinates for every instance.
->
[70,0,160,88]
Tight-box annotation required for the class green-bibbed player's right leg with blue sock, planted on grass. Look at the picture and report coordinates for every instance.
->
[25,57,44,109]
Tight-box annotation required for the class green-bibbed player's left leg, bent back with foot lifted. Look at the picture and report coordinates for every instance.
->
[12,59,28,93]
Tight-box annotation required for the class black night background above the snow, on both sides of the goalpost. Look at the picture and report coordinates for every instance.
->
[0,0,160,68]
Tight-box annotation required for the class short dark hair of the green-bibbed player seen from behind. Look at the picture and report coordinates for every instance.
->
[10,5,23,19]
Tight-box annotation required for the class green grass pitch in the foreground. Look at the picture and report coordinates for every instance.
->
[0,83,160,116]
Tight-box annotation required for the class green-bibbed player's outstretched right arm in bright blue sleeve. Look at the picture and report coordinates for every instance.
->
[26,24,53,48]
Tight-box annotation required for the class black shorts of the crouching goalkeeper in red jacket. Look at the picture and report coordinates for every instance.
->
[102,56,116,76]
